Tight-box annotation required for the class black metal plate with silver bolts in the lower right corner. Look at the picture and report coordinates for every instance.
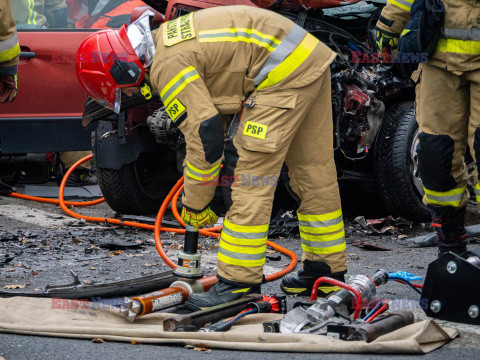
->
[420,251,480,325]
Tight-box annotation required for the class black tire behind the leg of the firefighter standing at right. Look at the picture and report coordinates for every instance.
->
[375,101,431,222]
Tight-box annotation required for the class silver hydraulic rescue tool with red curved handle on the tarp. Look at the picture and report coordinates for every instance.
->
[276,270,406,335]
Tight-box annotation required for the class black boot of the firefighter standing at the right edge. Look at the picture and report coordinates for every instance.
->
[432,206,467,257]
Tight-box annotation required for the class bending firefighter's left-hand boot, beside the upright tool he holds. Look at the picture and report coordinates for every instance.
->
[185,280,261,311]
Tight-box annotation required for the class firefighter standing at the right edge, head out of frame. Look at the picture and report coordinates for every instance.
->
[377,0,480,256]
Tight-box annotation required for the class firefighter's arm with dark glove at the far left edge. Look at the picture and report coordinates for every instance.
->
[0,0,20,103]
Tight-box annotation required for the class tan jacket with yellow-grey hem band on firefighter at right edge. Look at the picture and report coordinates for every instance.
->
[377,0,480,72]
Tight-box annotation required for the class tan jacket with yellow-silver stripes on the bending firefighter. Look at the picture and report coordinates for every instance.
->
[150,6,335,211]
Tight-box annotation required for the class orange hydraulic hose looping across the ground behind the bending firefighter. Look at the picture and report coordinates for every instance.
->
[10,155,297,281]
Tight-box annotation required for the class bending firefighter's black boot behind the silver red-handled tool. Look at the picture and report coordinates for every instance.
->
[280,260,346,297]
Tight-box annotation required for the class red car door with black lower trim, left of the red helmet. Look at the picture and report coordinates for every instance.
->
[0,11,94,154]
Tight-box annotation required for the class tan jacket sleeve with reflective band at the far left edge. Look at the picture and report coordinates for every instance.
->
[0,0,20,75]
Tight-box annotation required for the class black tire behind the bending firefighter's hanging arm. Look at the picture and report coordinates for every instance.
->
[97,152,181,215]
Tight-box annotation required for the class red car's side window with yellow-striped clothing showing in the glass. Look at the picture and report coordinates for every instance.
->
[12,0,68,29]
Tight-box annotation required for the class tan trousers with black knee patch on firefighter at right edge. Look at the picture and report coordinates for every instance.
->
[417,63,480,208]
